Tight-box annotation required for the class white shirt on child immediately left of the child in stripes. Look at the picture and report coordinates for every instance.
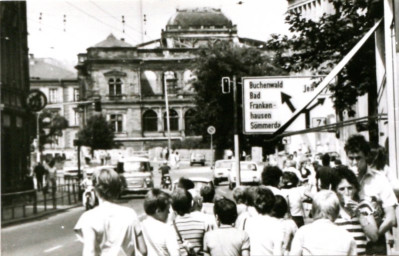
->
[141,216,180,256]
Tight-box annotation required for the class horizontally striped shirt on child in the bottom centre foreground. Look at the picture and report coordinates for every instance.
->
[172,213,207,256]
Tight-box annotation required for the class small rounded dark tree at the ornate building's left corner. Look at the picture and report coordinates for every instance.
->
[77,115,117,156]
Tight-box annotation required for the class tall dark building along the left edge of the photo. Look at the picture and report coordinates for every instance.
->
[0,1,31,193]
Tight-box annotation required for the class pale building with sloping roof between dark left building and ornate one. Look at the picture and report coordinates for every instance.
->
[29,54,81,156]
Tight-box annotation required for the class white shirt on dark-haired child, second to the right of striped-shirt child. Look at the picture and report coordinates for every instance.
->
[245,215,284,256]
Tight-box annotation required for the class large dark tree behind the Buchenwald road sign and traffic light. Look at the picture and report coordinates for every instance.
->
[192,42,285,157]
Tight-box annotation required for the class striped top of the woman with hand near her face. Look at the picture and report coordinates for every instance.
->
[335,211,367,255]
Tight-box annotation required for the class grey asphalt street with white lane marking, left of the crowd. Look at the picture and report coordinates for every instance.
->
[1,166,231,256]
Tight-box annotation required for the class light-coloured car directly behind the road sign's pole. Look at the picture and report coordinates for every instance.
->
[228,161,263,190]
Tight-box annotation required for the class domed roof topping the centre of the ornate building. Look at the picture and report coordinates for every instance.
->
[167,8,233,28]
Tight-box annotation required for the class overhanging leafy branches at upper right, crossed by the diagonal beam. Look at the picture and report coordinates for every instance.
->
[268,0,376,115]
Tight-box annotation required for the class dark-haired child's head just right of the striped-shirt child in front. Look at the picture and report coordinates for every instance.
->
[213,197,238,225]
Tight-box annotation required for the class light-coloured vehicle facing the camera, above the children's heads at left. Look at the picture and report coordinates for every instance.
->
[121,157,154,194]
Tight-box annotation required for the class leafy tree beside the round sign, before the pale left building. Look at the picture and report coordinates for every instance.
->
[39,110,68,152]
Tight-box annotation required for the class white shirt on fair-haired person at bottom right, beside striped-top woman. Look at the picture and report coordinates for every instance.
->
[290,219,356,256]
